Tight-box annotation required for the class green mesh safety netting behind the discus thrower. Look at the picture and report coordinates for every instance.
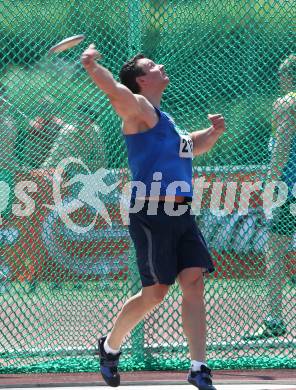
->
[0,0,296,373]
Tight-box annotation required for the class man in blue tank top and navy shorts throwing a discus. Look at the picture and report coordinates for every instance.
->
[82,45,225,390]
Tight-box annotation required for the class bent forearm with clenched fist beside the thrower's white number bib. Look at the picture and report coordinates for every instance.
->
[190,114,226,156]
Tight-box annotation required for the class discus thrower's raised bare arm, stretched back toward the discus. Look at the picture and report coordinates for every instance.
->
[81,44,142,120]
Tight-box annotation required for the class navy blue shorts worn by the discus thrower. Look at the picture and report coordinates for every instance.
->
[129,202,214,287]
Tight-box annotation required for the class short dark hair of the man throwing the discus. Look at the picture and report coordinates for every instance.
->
[119,54,146,93]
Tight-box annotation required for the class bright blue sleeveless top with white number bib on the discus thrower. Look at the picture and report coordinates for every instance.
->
[124,108,193,198]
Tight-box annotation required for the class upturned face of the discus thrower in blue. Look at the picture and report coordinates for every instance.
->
[137,58,170,90]
